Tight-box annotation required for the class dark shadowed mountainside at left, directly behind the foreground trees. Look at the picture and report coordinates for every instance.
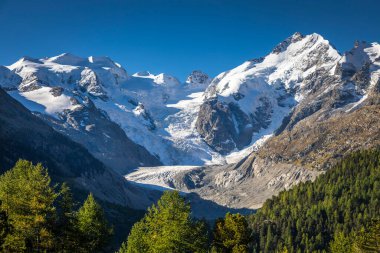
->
[0,89,160,208]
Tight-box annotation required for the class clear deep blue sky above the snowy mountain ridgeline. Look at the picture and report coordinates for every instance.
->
[0,0,380,80]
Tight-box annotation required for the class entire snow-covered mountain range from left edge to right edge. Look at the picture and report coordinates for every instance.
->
[0,33,379,179]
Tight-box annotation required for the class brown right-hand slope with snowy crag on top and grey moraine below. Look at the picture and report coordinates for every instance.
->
[183,37,380,208]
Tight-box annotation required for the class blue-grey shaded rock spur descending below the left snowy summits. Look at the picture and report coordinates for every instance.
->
[37,98,161,175]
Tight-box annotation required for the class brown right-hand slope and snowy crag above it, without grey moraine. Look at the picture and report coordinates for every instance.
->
[258,42,380,169]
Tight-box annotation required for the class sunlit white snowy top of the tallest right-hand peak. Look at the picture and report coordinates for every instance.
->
[209,33,341,102]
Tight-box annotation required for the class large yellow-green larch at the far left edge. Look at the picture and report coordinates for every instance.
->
[0,160,57,252]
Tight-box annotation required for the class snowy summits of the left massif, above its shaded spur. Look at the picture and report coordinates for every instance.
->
[8,53,128,94]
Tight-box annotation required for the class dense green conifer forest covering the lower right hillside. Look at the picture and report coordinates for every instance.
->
[249,149,380,252]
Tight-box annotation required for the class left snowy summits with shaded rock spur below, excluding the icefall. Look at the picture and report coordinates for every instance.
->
[2,54,160,174]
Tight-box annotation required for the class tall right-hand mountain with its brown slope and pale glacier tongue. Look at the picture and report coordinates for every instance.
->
[127,33,380,211]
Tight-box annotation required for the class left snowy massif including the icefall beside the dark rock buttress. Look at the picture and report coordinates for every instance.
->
[0,54,223,173]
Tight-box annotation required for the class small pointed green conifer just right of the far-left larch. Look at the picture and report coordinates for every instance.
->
[76,194,112,252]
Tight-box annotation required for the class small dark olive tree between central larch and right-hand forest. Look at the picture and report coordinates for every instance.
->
[213,213,251,253]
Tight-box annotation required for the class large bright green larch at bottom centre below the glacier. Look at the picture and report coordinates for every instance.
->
[119,191,208,253]
